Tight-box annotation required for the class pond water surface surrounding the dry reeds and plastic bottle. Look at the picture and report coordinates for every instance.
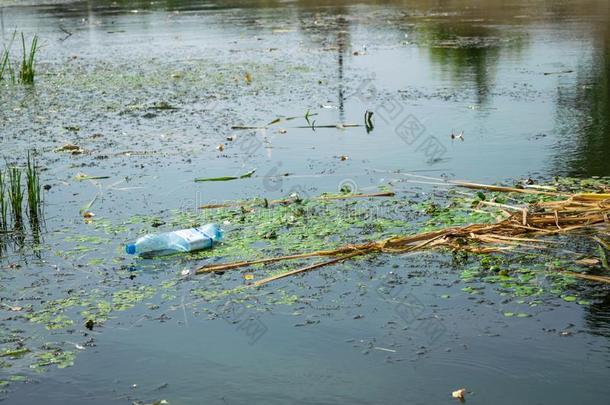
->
[0,0,610,404]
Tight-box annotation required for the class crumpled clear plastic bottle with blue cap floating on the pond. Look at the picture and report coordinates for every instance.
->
[125,224,223,256]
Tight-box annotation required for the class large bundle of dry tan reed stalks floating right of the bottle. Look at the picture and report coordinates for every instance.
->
[196,181,610,286]
